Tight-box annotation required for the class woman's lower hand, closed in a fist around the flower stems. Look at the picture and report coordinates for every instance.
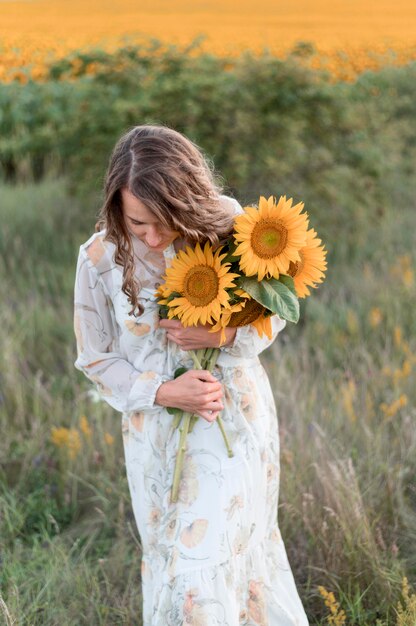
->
[155,370,224,422]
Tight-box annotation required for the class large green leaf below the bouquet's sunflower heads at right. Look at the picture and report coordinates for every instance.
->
[238,276,299,324]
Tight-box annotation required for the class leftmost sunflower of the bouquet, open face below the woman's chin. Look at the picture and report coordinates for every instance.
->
[158,242,238,326]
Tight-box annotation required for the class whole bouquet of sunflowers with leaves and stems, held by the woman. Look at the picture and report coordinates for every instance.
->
[156,196,327,502]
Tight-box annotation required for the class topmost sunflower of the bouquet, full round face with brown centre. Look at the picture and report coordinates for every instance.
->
[234,196,308,280]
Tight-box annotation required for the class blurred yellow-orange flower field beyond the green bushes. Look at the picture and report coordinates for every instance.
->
[0,0,416,82]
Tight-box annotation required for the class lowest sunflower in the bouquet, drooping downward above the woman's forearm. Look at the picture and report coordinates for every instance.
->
[212,289,272,343]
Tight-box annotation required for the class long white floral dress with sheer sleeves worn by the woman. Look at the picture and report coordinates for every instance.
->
[74,196,308,626]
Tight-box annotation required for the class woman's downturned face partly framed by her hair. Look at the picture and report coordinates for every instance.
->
[121,188,179,252]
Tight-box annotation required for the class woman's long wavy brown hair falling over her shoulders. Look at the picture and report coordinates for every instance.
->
[95,124,237,315]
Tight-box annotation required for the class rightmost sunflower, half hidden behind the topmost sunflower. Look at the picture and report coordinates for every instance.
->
[287,228,327,298]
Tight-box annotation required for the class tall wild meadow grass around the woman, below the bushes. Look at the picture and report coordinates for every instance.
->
[0,168,416,626]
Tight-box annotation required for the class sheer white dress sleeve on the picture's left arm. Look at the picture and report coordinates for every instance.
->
[74,246,168,412]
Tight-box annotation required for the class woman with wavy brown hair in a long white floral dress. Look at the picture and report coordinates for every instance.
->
[74,125,308,626]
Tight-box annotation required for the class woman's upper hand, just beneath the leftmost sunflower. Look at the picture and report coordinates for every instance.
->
[159,319,237,350]
